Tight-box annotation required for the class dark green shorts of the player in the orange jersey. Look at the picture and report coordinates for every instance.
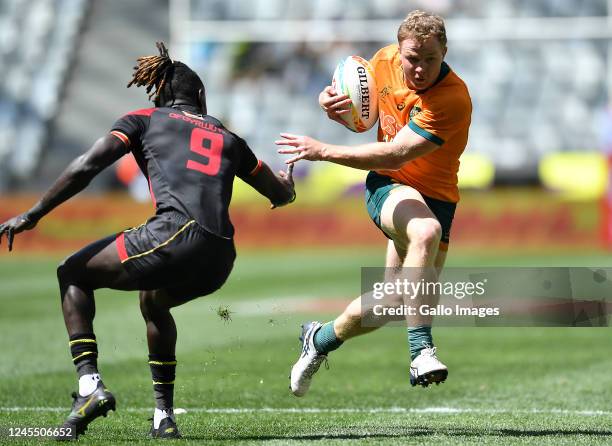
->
[366,171,457,251]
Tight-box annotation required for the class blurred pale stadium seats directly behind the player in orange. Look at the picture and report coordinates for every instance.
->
[191,0,608,180]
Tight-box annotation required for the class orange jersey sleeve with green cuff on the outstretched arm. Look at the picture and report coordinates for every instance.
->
[408,93,470,146]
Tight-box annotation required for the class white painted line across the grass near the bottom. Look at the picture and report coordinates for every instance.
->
[0,406,612,417]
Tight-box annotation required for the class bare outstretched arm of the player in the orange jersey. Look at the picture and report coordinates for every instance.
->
[275,126,440,170]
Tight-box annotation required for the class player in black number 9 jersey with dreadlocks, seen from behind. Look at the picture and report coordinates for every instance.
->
[0,43,295,438]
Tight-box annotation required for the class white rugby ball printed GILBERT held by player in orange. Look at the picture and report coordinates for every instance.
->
[332,56,378,133]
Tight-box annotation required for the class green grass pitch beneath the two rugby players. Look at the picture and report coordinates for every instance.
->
[0,249,612,445]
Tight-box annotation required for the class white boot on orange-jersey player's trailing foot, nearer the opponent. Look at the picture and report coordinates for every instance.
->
[289,321,327,396]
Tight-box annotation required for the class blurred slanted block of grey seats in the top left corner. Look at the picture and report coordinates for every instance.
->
[0,0,88,189]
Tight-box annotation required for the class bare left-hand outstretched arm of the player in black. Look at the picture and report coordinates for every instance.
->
[0,134,125,251]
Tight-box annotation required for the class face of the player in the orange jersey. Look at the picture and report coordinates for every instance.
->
[399,37,446,90]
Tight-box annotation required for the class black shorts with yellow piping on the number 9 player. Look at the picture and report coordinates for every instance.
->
[116,211,236,299]
